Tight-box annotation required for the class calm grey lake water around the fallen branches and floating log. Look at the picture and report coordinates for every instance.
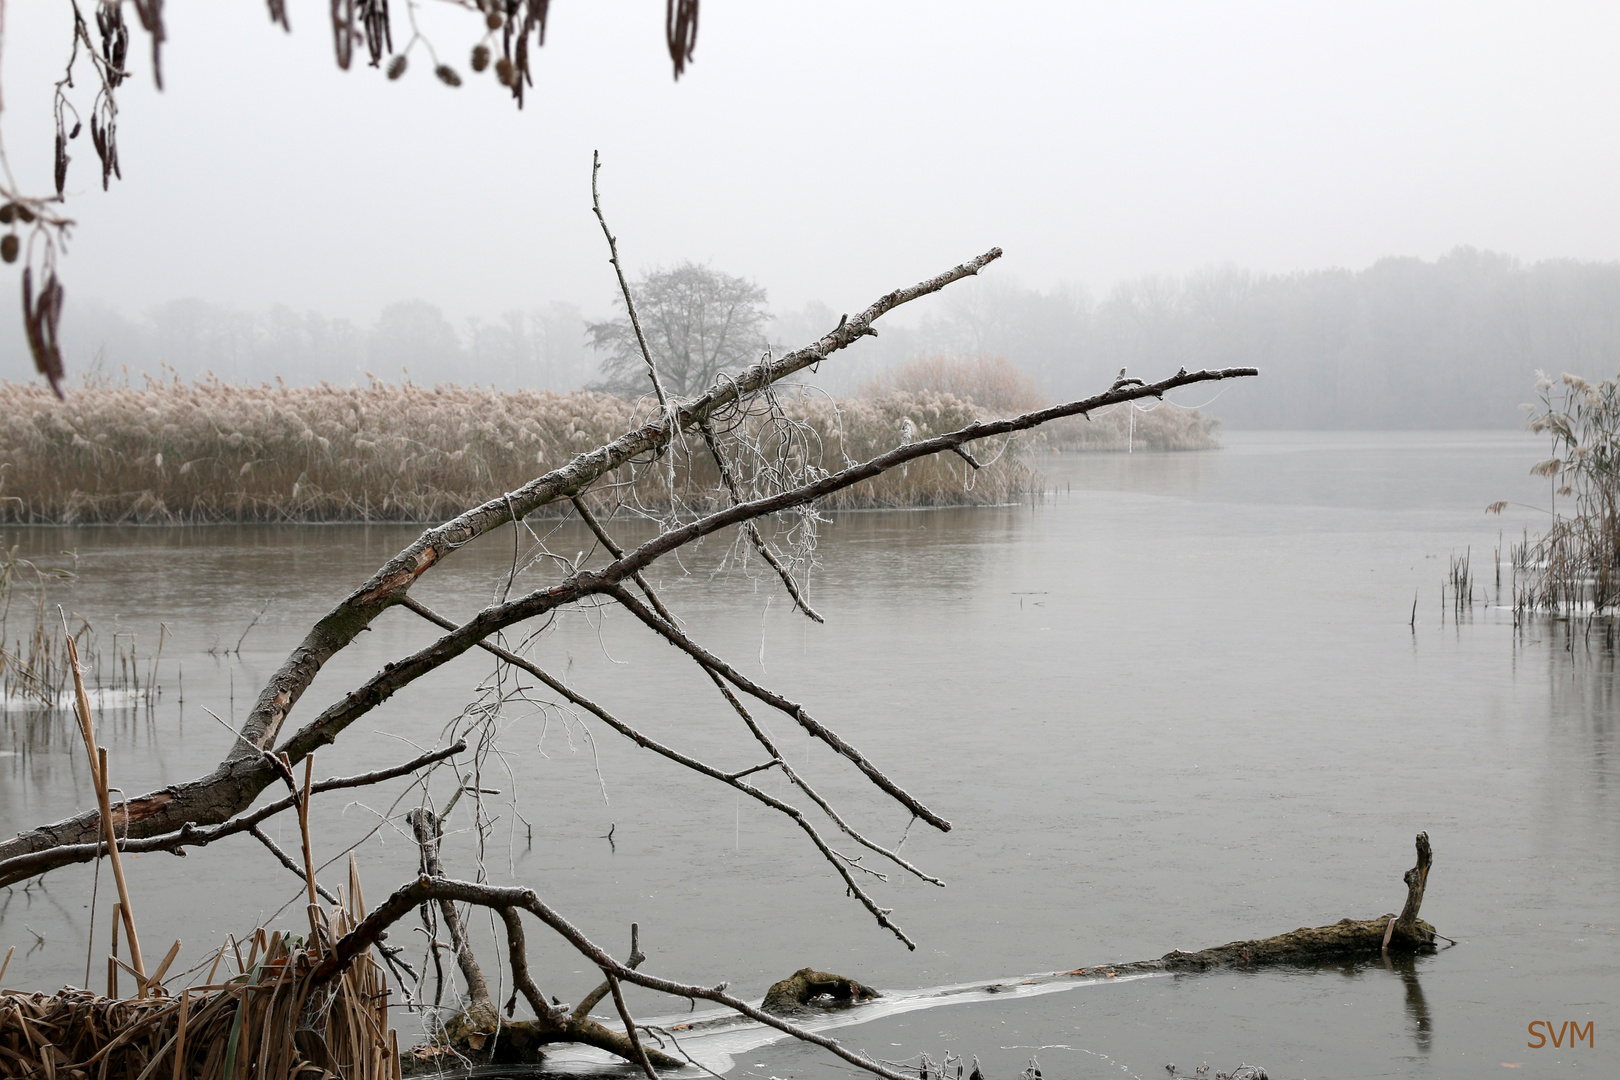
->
[0,432,1620,1080]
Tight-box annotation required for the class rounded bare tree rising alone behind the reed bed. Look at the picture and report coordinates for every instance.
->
[586,262,771,397]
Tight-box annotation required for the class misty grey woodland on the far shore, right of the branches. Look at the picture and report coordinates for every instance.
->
[889,248,1620,429]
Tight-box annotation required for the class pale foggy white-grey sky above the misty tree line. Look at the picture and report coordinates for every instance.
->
[0,0,1620,379]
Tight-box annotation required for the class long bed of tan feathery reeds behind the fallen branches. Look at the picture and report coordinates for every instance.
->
[0,379,1034,525]
